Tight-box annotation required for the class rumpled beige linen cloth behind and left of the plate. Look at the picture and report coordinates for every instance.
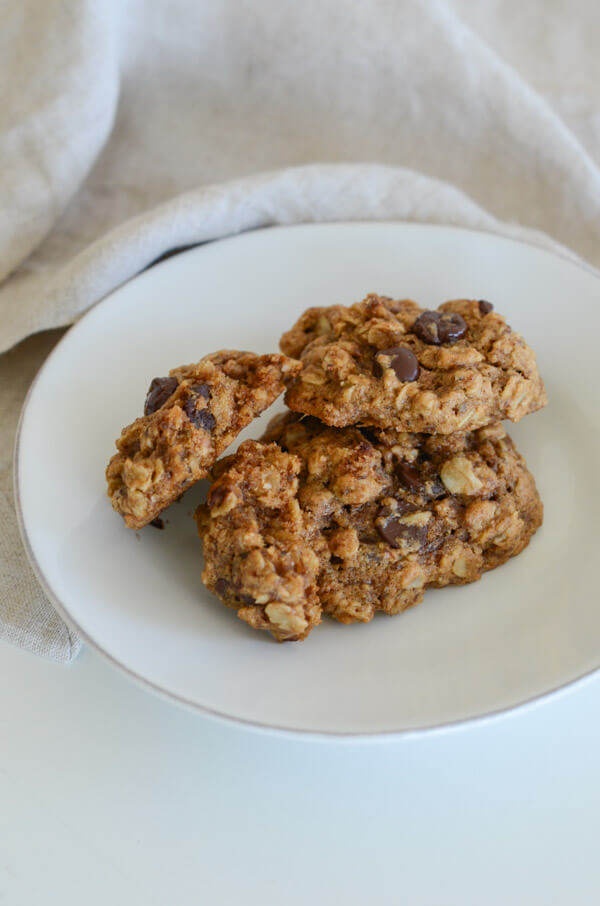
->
[0,0,600,661]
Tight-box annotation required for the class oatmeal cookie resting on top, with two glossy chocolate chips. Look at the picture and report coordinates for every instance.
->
[281,295,546,434]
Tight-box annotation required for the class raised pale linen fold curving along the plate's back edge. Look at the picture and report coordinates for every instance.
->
[0,164,576,352]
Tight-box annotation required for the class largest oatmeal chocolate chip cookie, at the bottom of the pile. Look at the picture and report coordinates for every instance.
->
[196,414,542,641]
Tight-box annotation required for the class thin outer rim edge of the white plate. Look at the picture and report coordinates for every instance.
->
[13,220,600,742]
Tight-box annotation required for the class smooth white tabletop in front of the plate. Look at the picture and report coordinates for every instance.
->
[0,643,600,906]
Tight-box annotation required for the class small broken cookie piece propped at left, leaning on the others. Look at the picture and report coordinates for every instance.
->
[106,350,301,529]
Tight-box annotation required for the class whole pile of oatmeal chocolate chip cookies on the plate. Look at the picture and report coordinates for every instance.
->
[107,295,546,641]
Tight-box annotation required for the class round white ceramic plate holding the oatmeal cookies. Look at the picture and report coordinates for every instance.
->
[16,223,600,735]
